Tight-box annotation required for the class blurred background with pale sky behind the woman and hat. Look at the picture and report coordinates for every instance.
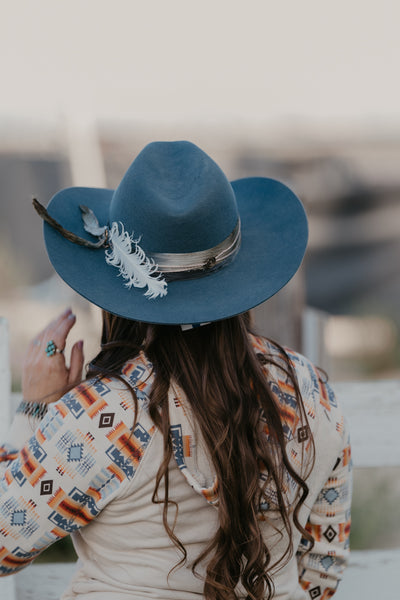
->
[0,0,400,547]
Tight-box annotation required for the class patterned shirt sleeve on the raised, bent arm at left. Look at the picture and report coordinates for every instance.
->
[0,379,152,575]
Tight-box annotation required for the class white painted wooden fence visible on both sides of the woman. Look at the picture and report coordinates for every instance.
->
[0,320,400,600]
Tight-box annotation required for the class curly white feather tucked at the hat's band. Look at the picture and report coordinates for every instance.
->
[105,222,167,298]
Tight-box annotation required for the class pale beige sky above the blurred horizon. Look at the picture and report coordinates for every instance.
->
[0,0,400,125]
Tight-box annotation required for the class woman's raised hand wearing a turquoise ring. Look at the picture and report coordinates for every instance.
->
[22,309,84,403]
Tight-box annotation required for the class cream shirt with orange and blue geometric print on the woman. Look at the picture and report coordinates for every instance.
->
[0,337,351,600]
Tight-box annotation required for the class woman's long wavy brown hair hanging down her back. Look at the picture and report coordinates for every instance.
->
[87,312,313,600]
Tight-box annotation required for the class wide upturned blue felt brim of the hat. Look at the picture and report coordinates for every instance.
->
[44,177,308,325]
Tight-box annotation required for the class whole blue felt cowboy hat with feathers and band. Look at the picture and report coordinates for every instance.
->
[36,142,307,324]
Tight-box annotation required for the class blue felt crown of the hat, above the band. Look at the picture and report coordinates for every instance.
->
[109,142,239,253]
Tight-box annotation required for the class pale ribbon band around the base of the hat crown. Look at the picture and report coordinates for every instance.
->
[149,219,241,279]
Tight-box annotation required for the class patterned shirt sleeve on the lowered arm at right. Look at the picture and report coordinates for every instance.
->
[297,384,352,600]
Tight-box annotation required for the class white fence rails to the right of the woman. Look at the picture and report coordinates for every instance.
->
[334,381,400,600]
